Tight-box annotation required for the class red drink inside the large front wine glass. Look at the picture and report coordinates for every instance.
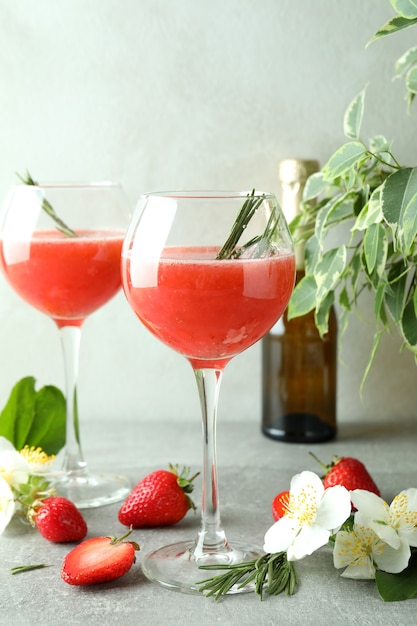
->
[122,248,295,368]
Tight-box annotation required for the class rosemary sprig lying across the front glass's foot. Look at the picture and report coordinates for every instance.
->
[196,552,298,600]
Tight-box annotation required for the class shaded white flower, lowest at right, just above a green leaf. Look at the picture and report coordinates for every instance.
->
[333,513,410,579]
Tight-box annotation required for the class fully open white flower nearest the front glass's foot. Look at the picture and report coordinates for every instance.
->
[264,471,351,561]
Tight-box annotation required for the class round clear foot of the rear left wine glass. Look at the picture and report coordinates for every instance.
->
[52,472,131,509]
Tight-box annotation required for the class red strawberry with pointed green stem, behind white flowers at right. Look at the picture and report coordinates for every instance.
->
[312,455,381,496]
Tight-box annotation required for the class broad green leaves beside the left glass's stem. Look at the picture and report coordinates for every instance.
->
[0,376,66,455]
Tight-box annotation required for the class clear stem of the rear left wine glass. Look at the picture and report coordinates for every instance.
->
[59,326,86,474]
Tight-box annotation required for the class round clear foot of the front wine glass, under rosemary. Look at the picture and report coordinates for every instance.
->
[142,541,264,595]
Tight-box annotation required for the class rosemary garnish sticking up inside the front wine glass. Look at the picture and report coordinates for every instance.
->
[216,189,279,259]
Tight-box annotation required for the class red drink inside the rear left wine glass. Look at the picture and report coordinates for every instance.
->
[0,230,124,326]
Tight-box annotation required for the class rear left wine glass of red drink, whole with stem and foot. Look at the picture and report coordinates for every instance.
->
[0,177,130,508]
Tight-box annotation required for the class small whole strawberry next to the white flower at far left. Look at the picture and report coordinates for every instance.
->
[29,496,87,543]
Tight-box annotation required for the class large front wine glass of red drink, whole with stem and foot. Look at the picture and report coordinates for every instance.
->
[122,192,295,593]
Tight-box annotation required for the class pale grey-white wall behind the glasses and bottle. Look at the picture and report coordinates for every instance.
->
[0,0,417,423]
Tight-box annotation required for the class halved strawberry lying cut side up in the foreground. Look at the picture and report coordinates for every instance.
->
[61,530,139,585]
